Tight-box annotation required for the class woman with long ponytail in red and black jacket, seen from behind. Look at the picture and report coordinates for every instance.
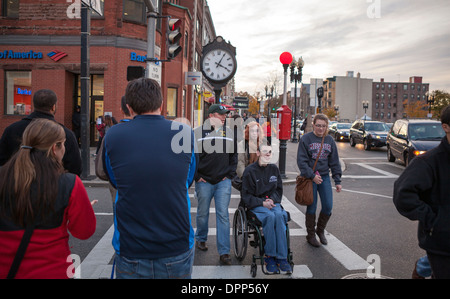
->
[0,119,96,278]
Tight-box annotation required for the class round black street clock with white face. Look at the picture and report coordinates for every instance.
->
[200,36,237,103]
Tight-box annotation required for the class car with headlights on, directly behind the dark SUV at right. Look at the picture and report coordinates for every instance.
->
[349,119,389,151]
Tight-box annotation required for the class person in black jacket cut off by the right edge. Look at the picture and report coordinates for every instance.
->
[394,106,450,279]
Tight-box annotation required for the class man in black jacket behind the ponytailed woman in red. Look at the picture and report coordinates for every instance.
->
[0,89,81,176]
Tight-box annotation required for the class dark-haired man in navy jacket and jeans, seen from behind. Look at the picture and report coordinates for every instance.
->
[102,78,197,279]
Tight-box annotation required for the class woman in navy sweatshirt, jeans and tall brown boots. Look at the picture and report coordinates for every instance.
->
[297,114,342,247]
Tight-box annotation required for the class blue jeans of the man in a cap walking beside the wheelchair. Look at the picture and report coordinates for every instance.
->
[195,179,231,255]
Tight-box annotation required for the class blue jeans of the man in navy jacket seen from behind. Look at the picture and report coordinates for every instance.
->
[115,246,195,279]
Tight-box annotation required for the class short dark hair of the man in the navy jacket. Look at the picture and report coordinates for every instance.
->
[125,78,163,114]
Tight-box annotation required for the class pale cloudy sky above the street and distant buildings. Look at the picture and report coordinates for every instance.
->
[207,0,450,94]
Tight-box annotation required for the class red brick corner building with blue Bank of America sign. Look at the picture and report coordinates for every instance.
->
[0,0,215,145]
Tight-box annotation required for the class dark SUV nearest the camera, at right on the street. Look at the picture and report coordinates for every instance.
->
[387,119,445,165]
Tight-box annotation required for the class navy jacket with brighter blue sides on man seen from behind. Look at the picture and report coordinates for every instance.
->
[103,115,197,259]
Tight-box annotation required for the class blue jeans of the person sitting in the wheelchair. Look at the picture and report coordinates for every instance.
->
[251,204,288,259]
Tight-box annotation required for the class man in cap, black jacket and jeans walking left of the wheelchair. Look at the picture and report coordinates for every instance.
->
[194,104,237,265]
